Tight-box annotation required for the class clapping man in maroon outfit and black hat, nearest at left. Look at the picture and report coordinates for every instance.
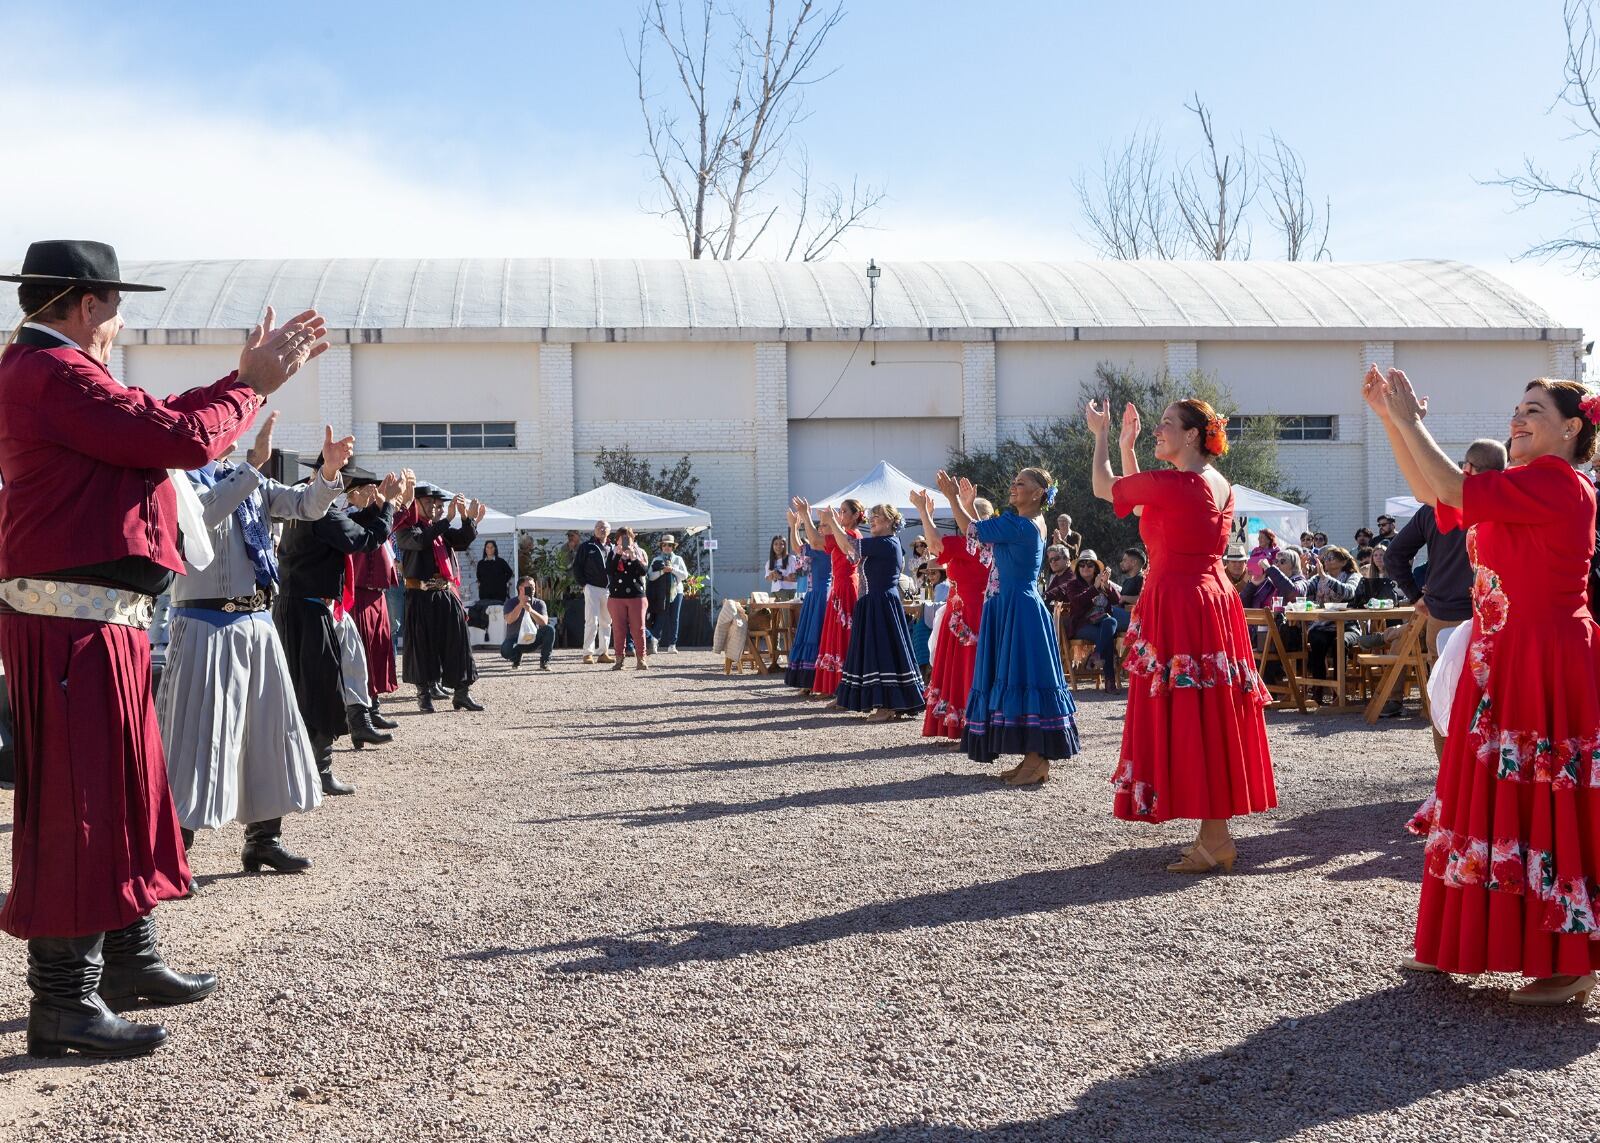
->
[0,242,326,1057]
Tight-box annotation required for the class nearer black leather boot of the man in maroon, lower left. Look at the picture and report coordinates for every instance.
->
[27,933,166,1060]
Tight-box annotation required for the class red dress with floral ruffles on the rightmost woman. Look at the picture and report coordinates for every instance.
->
[1411,456,1600,977]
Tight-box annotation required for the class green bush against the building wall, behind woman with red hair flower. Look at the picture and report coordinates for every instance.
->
[950,362,1304,550]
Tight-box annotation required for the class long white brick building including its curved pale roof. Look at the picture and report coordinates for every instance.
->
[6,259,1582,591]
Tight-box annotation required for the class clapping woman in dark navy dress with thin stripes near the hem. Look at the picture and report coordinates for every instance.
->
[822,504,923,722]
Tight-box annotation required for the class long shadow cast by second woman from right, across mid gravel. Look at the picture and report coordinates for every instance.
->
[454,845,1195,973]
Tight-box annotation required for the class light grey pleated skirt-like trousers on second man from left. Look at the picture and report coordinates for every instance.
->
[155,610,322,829]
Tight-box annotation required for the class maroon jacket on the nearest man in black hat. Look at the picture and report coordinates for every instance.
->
[0,330,262,580]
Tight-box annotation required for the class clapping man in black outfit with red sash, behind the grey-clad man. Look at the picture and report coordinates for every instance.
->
[272,456,402,794]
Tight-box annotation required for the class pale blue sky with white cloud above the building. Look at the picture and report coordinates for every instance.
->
[9,0,1600,330]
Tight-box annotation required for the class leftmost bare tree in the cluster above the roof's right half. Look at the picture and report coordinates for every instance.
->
[1072,130,1187,259]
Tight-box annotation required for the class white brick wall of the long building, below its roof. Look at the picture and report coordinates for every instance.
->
[122,329,1573,594]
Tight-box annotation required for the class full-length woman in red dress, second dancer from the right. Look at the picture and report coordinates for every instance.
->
[1088,400,1278,872]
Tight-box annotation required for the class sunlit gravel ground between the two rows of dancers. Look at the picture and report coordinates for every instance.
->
[0,653,1600,1143]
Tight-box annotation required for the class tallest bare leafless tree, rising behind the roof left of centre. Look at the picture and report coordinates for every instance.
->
[629,0,883,261]
